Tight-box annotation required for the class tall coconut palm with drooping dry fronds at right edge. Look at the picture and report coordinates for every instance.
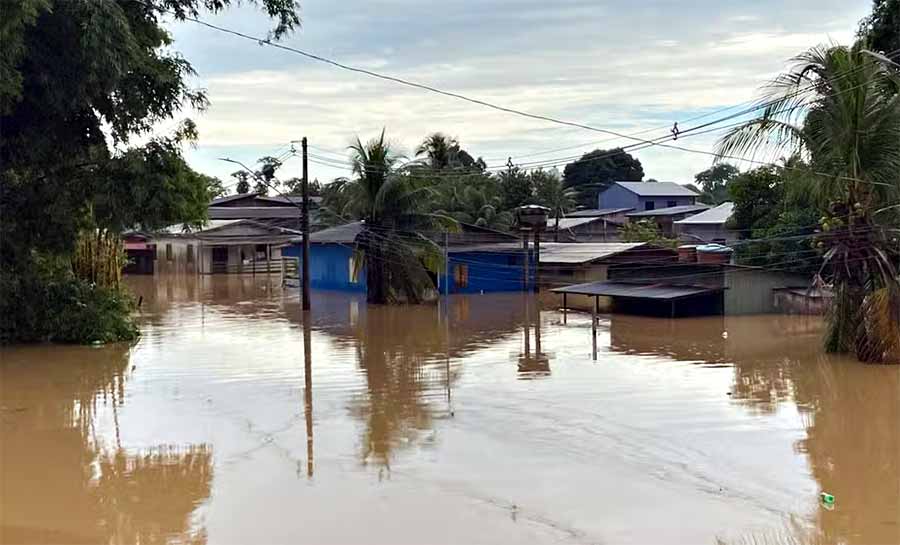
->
[718,43,900,362]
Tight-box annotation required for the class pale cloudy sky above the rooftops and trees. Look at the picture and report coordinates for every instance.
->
[161,0,870,191]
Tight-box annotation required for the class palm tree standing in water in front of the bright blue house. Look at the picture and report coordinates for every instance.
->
[339,130,454,304]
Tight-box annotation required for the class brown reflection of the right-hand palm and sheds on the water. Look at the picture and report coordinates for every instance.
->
[610,316,900,545]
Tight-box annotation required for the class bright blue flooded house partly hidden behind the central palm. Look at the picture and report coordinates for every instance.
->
[282,222,533,293]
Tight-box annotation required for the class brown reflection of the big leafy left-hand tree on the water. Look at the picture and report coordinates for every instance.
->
[0,346,212,543]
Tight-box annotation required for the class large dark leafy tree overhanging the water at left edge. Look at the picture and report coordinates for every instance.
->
[0,0,299,340]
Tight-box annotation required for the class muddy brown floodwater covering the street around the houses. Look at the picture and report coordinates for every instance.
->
[0,277,900,545]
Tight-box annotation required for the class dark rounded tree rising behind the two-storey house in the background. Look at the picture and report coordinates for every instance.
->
[563,148,644,208]
